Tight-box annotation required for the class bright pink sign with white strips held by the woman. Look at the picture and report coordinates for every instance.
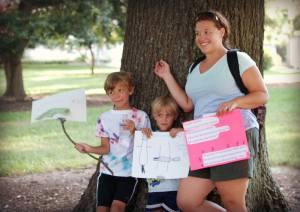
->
[183,109,250,170]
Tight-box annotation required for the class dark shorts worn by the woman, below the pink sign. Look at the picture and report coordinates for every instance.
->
[189,128,259,181]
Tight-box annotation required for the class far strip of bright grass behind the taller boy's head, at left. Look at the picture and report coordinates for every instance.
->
[0,64,118,95]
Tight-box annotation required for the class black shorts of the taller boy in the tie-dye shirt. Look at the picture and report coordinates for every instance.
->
[96,174,138,207]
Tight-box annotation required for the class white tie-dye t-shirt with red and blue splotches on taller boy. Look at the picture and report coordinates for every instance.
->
[96,108,150,177]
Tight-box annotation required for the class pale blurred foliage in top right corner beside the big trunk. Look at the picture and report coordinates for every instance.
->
[264,0,300,69]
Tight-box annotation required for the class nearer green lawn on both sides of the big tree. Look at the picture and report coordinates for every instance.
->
[0,87,300,176]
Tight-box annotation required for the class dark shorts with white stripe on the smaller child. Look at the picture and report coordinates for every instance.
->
[146,191,179,212]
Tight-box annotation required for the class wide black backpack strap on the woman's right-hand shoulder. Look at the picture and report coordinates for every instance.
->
[227,49,249,94]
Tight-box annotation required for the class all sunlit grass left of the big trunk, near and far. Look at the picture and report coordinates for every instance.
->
[0,63,118,176]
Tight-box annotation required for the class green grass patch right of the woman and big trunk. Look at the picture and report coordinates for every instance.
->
[266,87,300,167]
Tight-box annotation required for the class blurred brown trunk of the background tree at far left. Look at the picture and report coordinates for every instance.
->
[3,54,26,100]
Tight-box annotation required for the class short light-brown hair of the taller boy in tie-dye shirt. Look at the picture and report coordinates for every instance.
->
[104,71,134,94]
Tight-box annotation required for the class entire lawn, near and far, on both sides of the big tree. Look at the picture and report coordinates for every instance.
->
[0,64,300,176]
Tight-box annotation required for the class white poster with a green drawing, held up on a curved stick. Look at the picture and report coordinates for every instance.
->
[31,89,86,123]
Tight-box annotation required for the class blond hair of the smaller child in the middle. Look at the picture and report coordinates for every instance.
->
[151,96,179,118]
